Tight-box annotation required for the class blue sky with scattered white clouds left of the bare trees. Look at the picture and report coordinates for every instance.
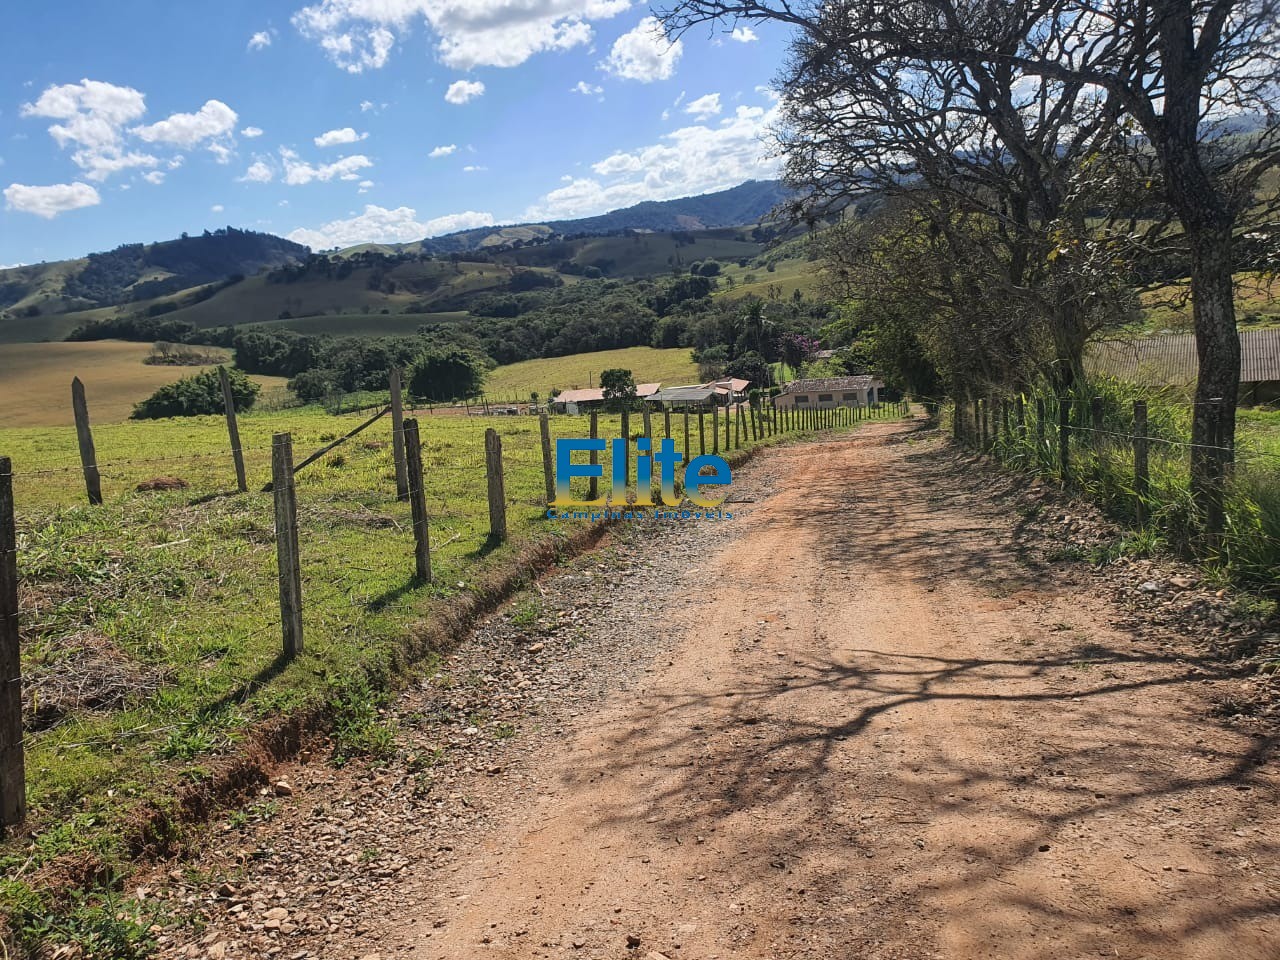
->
[0,0,786,265]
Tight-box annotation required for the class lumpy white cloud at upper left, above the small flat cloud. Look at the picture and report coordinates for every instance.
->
[19,79,160,180]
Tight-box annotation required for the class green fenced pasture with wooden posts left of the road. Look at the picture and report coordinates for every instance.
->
[0,368,906,828]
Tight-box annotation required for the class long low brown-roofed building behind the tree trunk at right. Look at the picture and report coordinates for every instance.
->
[1084,329,1280,404]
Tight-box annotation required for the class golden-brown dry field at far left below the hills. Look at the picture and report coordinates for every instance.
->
[0,340,284,426]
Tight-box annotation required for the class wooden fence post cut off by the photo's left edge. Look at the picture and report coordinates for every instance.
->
[0,457,27,832]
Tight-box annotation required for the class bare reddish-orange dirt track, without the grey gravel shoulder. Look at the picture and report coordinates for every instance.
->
[165,424,1280,960]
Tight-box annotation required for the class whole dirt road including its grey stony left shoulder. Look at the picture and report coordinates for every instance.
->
[154,422,1280,960]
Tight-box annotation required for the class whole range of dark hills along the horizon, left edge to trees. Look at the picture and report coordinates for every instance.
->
[0,180,808,343]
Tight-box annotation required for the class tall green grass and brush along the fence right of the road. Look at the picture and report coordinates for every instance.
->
[951,380,1280,589]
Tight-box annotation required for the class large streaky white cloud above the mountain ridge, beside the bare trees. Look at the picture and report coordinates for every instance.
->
[524,106,781,221]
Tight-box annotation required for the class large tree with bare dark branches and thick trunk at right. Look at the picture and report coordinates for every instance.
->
[664,0,1280,535]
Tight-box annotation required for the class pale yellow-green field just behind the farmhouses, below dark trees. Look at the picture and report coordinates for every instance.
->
[484,347,698,399]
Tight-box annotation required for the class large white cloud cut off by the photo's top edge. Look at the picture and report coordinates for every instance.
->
[293,0,632,73]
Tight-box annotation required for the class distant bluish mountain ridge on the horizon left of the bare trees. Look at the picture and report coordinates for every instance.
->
[413,180,792,253]
